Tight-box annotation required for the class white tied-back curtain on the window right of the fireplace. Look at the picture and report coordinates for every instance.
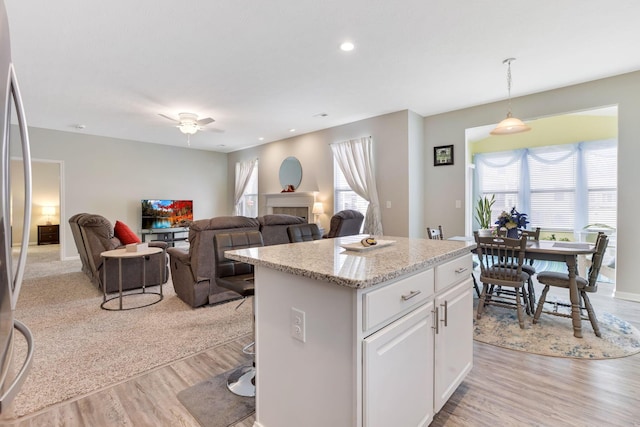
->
[331,136,383,236]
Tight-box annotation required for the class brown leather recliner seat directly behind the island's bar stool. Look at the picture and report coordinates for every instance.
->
[167,216,260,308]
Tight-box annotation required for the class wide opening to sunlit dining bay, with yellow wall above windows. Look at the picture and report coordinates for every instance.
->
[465,106,618,288]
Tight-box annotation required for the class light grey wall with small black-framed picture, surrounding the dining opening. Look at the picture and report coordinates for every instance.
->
[424,72,640,301]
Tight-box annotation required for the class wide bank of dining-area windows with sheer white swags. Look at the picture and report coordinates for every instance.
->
[474,140,617,230]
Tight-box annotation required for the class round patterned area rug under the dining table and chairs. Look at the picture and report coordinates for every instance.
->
[473,298,640,359]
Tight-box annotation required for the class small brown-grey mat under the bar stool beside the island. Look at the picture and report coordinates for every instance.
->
[178,370,256,427]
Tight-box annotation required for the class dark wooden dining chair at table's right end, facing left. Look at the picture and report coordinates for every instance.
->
[533,233,609,337]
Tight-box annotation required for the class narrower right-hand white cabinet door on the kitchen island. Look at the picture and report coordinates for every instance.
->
[434,277,473,412]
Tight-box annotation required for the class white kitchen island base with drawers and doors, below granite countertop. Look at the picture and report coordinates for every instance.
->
[254,251,473,427]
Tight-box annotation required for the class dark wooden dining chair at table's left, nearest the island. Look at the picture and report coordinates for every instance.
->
[474,232,529,329]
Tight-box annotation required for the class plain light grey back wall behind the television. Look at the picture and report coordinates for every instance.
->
[12,128,229,258]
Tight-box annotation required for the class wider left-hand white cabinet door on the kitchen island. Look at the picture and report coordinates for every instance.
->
[362,301,433,427]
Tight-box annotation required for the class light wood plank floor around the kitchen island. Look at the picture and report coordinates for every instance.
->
[6,285,640,427]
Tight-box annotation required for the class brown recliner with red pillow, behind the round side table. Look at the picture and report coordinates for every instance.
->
[69,214,168,293]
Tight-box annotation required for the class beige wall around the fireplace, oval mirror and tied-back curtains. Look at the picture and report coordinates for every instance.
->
[227,110,424,237]
